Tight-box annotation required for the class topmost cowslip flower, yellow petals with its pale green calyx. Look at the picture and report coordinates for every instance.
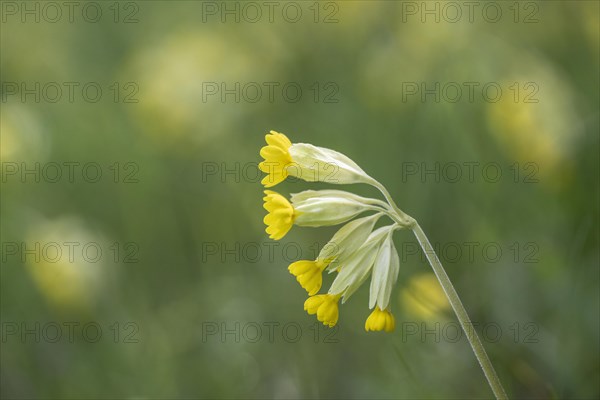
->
[258,131,373,188]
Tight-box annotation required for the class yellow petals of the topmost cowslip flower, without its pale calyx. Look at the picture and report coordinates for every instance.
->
[258,131,292,187]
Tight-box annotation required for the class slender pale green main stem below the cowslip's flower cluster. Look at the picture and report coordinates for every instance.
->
[412,221,508,399]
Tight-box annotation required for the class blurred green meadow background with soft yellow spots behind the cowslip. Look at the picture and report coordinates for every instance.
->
[0,1,600,399]
